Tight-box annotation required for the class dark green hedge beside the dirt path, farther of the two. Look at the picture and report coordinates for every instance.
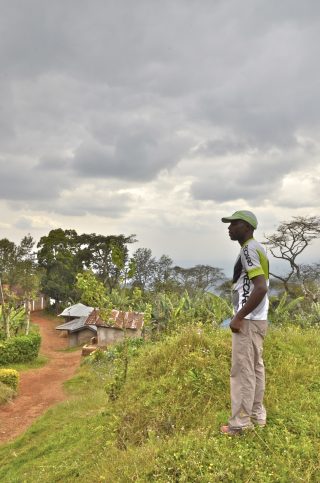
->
[0,332,41,366]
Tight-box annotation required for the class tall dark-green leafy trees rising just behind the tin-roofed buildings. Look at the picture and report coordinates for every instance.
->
[38,228,135,305]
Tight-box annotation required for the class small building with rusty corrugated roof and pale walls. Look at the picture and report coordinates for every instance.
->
[85,310,144,347]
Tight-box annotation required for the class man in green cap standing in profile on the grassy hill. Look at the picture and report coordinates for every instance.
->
[220,210,269,435]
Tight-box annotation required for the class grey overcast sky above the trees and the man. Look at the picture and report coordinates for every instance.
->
[0,0,320,275]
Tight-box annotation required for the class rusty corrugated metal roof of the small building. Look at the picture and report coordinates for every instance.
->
[85,309,144,330]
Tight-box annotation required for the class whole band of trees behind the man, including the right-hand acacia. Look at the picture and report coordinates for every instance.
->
[0,216,320,336]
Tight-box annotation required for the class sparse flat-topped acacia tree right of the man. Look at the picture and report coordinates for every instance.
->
[265,216,320,301]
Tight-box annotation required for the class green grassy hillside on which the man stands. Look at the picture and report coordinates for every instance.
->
[0,328,320,483]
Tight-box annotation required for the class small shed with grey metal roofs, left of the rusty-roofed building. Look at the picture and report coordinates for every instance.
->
[56,303,97,347]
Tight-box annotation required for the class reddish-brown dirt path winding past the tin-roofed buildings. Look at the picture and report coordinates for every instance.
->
[0,312,81,443]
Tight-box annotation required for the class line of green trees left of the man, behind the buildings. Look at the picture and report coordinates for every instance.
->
[0,228,225,305]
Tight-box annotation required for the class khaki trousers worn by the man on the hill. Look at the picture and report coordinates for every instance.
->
[229,319,268,428]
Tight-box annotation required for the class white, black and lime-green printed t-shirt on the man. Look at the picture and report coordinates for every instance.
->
[232,238,269,320]
